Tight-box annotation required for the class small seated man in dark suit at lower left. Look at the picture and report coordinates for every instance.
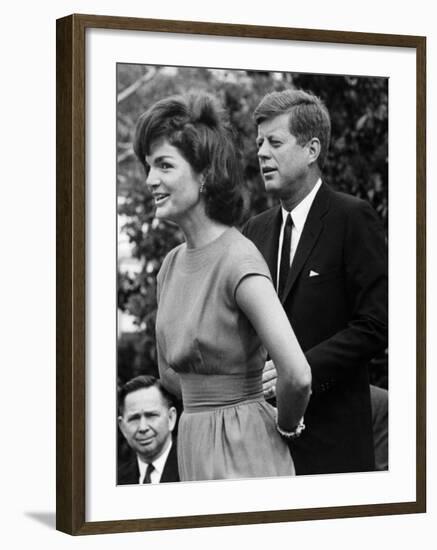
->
[117,376,179,485]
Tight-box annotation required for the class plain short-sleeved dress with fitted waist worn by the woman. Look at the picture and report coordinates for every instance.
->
[156,228,295,481]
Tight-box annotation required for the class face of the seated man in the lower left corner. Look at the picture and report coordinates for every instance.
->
[118,386,176,462]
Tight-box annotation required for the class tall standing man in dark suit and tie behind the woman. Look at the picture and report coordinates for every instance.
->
[243,90,388,475]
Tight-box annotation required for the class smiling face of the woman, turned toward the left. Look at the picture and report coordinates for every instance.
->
[146,139,203,224]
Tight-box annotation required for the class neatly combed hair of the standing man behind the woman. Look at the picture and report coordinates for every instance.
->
[253,90,331,168]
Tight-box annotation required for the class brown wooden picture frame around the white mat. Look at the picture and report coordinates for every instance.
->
[56,15,426,535]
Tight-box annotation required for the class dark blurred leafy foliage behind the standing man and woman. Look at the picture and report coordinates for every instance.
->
[117,64,388,387]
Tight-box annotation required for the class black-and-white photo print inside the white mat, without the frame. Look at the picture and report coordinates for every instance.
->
[114,63,390,491]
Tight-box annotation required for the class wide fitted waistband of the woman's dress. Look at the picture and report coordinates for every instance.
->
[179,371,264,412]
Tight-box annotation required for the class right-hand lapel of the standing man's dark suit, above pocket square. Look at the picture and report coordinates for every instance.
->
[282,184,329,303]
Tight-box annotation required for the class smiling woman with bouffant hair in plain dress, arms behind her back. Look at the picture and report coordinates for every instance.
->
[134,93,311,481]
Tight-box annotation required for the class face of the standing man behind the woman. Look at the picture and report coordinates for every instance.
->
[256,113,310,200]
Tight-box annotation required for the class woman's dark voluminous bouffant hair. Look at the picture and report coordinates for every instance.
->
[134,92,243,225]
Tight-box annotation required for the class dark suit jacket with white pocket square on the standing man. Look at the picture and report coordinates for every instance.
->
[243,184,388,474]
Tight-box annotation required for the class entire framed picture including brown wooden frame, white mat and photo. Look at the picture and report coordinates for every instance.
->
[53,15,425,534]
